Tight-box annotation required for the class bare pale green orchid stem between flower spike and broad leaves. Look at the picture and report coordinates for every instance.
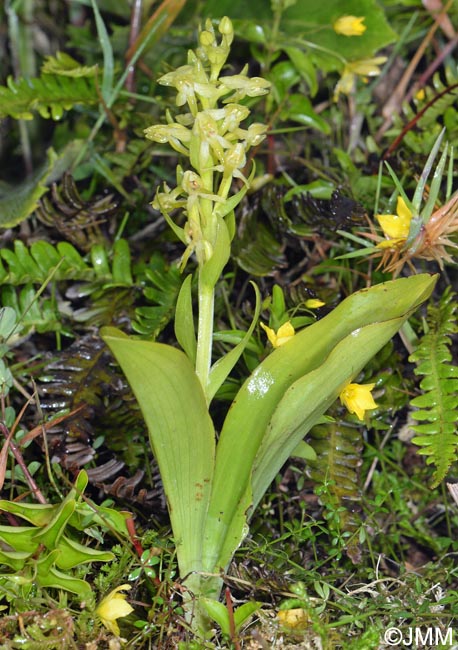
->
[196,273,215,396]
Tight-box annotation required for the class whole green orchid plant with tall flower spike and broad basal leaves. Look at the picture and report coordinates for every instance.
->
[102,18,435,635]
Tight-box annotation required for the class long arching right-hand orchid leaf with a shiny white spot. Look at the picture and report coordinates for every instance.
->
[204,275,436,571]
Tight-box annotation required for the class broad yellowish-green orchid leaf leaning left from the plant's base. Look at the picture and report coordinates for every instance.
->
[102,327,215,584]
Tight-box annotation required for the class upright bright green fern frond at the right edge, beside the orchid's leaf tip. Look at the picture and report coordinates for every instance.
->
[410,291,458,487]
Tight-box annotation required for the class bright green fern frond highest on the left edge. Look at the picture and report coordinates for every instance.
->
[0,73,100,120]
